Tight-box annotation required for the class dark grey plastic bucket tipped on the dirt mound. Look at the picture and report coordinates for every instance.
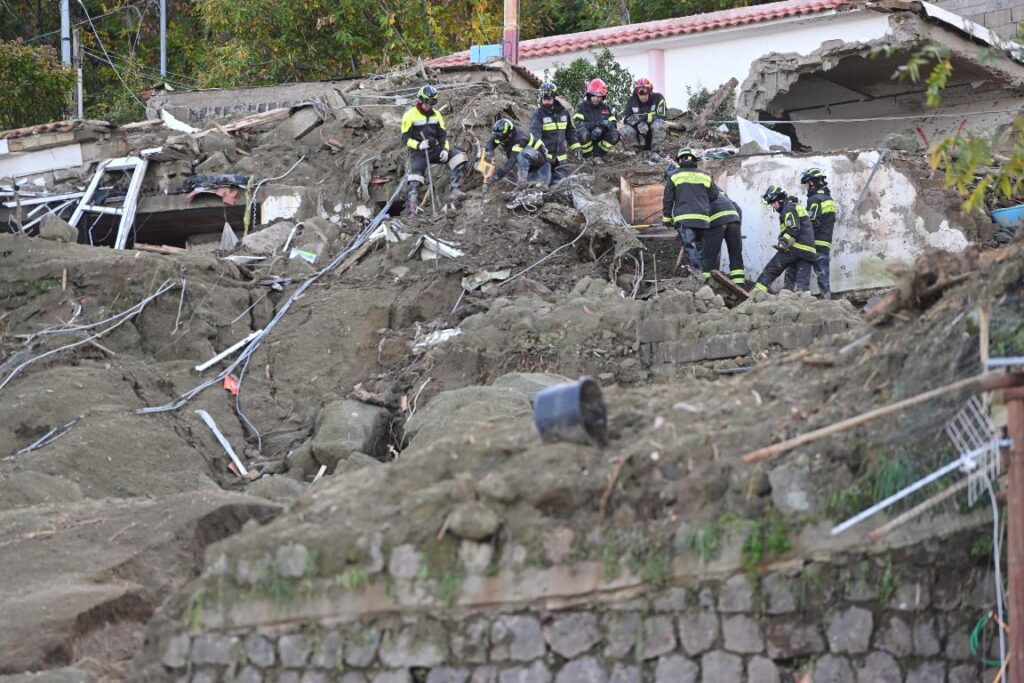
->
[534,377,608,445]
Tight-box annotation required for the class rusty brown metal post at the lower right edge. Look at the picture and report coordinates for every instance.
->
[1002,387,1024,683]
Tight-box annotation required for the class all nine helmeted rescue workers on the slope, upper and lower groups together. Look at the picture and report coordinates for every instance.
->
[401,78,836,298]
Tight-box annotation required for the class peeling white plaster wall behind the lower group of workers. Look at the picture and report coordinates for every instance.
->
[716,152,968,292]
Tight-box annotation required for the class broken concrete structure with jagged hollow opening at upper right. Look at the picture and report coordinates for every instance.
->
[736,12,1024,151]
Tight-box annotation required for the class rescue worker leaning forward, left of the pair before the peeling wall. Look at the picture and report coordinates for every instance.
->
[754,185,817,292]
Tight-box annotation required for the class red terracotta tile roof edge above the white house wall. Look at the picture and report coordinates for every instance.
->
[427,0,854,67]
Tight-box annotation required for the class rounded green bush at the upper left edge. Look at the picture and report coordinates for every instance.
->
[0,40,75,130]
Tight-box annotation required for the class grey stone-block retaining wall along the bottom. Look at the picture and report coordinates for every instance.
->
[153,558,990,683]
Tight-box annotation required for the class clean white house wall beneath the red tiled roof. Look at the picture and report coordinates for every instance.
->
[521,10,889,109]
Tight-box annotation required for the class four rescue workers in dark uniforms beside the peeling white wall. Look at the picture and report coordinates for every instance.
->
[662,147,836,299]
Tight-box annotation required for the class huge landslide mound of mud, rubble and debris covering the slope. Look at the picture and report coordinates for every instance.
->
[0,61,1022,681]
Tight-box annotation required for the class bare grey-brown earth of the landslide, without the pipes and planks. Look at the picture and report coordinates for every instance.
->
[0,62,1007,680]
